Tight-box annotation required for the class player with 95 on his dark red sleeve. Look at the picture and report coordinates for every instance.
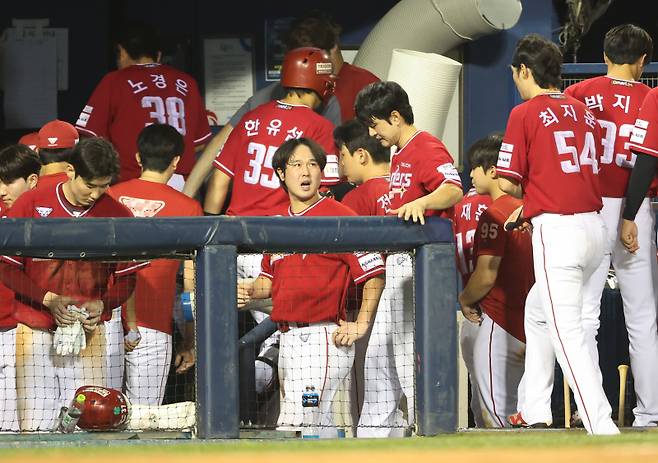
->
[459,135,535,428]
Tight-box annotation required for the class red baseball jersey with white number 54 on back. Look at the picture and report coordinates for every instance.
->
[497,93,603,218]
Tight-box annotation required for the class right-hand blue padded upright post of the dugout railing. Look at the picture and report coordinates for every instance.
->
[415,243,459,436]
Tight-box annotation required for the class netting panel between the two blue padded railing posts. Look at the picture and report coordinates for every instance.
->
[237,252,415,437]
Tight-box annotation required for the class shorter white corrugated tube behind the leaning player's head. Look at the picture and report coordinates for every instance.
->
[387,49,462,139]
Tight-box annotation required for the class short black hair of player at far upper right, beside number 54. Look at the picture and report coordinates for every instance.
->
[603,24,653,64]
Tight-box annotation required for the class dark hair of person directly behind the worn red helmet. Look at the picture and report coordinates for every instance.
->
[284,10,341,51]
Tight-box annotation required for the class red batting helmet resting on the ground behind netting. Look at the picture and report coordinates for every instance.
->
[75,386,130,431]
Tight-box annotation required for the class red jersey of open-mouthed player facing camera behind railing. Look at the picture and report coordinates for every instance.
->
[261,197,385,323]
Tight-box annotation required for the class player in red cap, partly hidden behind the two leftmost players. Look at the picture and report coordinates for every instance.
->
[36,119,80,187]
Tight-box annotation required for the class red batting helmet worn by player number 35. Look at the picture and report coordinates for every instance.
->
[281,47,336,102]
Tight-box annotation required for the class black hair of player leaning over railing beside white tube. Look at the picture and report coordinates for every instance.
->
[354,81,414,127]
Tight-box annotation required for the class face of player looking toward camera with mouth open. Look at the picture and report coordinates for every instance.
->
[283,145,322,203]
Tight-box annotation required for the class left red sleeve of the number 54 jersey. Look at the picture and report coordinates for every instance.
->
[496,105,528,181]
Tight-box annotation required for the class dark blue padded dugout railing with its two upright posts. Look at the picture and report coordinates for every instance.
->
[0,217,458,439]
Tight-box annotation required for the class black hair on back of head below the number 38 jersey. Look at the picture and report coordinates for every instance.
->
[137,124,185,173]
